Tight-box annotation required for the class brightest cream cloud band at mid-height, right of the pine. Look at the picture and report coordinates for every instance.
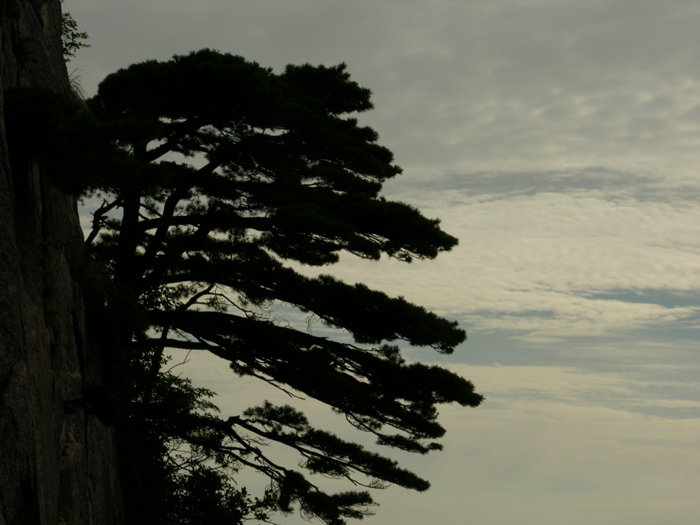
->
[312,180,700,340]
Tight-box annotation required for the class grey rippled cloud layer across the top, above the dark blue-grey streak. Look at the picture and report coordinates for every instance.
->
[69,0,700,182]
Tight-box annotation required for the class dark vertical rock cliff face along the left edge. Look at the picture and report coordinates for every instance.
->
[0,0,123,525]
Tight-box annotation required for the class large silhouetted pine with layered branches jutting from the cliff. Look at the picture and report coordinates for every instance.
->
[87,50,482,524]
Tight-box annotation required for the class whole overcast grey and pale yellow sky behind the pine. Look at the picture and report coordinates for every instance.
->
[65,0,700,525]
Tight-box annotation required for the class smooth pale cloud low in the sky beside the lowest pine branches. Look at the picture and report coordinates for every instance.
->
[176,355,700,525]
